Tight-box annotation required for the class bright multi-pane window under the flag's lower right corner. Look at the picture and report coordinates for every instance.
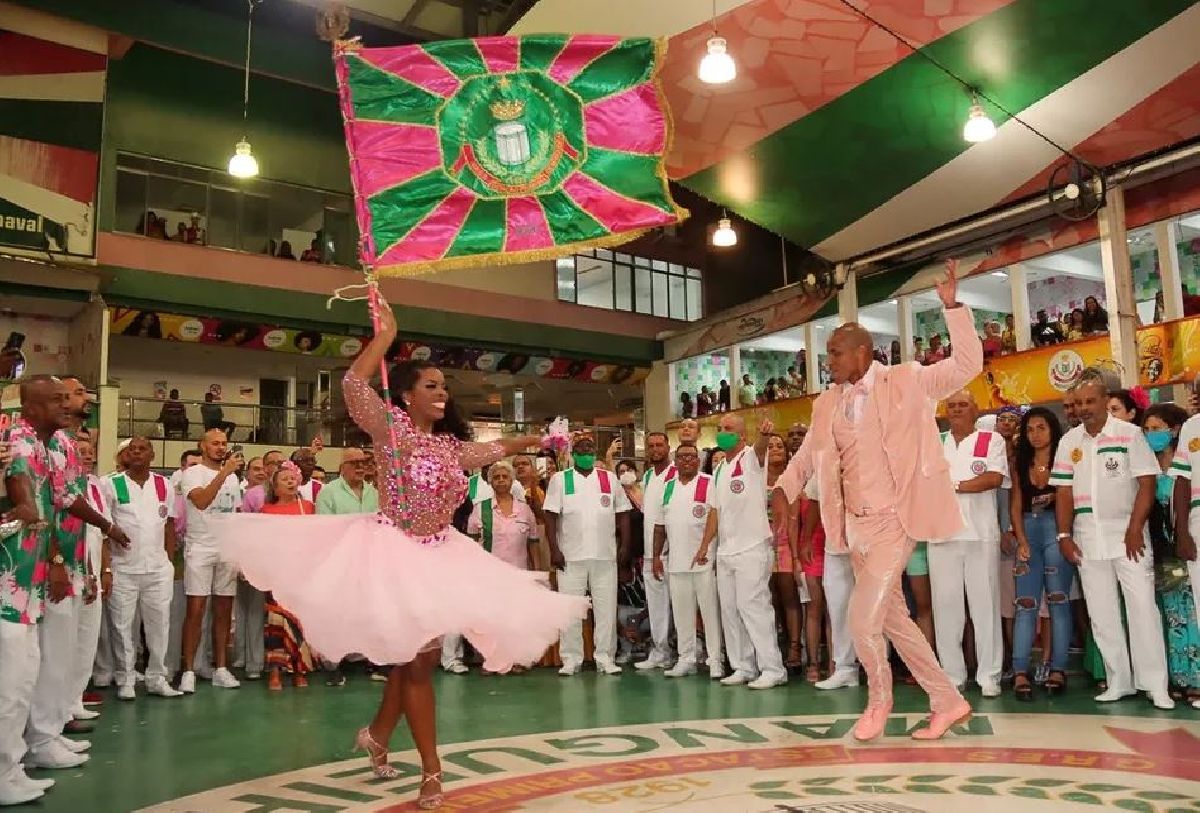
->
[557,248,704,321]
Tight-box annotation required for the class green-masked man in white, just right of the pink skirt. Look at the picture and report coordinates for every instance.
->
[542,433,634,676]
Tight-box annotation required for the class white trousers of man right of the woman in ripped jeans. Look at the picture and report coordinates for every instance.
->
[1079,556,1168,697]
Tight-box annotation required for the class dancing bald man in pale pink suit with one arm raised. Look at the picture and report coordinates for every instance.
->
[772,263,983,740]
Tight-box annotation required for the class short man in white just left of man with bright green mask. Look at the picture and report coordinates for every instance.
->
[646,444,725,680]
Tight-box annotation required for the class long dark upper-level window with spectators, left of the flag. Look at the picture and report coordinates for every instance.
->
[113,153,358,266]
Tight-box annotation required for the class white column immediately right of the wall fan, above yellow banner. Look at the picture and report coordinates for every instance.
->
[1099,187,1138,387]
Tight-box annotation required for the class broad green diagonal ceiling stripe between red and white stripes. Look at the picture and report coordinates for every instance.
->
[683,0,1194,246]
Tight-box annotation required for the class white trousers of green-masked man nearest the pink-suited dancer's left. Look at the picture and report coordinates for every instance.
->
[716,543,787,679]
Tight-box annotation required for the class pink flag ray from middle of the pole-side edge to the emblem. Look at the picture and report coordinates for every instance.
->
[350,121,442,198]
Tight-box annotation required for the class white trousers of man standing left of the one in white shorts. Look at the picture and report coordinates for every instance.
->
[108,567,174,686]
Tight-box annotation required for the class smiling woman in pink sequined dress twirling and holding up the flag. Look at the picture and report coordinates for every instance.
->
[218,303,588,809]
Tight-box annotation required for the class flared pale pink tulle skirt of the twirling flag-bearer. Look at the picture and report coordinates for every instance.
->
[210,513,589,672]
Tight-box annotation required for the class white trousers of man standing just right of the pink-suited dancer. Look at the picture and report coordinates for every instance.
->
[928,540,1004,686]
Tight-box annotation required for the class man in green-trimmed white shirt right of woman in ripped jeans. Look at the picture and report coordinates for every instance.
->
[1050,373,1175,709]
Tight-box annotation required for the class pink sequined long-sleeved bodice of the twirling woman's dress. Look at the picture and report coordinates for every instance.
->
[342,373,504,540]
